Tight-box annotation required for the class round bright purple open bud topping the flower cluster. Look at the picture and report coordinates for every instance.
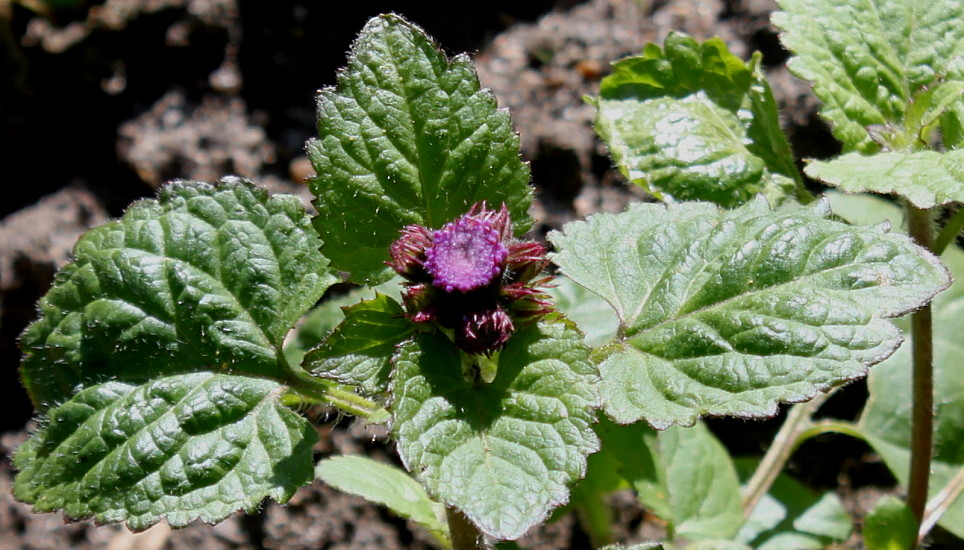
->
[424,215,509,292]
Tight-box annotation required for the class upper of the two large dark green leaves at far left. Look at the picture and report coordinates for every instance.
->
[20,178,335,410]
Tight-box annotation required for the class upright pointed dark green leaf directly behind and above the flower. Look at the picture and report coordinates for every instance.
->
[308,15,532,282]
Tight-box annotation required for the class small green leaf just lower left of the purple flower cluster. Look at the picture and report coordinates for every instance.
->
[304,293,412,393]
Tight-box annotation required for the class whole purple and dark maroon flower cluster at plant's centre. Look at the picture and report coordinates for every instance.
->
[387,203,551,354]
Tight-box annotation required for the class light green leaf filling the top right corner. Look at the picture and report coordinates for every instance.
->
[773,0,964,153]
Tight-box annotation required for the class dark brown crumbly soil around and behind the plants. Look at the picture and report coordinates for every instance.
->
[0,0,960,550]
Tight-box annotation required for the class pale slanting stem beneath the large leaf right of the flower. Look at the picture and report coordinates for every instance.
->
[743,393,829,517]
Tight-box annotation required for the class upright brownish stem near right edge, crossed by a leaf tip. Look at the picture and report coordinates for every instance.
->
[907,203,934,526]
